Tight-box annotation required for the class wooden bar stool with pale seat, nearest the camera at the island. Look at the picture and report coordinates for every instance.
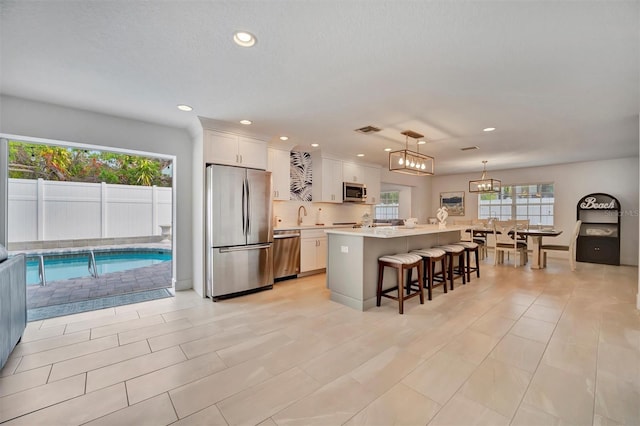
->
[376,253,424,314]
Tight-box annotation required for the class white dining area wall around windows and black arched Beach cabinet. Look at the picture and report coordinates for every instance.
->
[431,157,639,265]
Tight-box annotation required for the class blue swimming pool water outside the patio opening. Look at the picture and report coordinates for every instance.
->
[27,251,171,285]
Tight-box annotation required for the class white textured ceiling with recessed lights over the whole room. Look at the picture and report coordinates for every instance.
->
[0,0,640,174]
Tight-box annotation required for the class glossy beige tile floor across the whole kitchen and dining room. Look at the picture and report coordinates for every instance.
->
[0,260,640,426]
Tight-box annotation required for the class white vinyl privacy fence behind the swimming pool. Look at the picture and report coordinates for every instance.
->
[8,179,172,242]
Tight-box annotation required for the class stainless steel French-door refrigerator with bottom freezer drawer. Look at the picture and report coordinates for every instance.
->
[206,165,273,300]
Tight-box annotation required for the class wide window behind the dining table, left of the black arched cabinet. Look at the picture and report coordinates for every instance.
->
[478,183,554,226]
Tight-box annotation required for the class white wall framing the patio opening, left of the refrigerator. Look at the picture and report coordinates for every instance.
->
[0,95,192,290]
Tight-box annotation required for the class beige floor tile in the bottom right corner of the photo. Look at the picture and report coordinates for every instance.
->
[595,367,640,425]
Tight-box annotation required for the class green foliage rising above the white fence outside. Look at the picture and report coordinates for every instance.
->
[9,141,171,187]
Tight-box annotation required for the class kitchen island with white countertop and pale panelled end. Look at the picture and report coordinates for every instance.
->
[325,225,465,311]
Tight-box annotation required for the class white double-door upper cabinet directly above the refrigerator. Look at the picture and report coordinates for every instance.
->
[204,130,267,170]
